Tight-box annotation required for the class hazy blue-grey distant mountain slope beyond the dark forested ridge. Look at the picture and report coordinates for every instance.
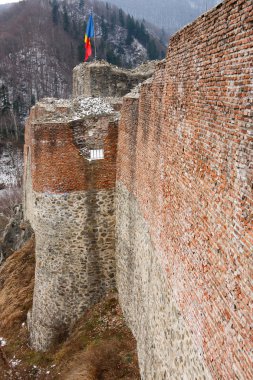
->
[109,0,221,35]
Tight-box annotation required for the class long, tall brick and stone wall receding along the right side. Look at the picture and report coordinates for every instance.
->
[116,0,253,380]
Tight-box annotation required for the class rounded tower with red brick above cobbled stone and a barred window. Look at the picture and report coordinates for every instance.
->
[24,101,117,350]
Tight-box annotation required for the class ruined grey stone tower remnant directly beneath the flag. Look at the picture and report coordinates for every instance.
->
[73,61,155,97]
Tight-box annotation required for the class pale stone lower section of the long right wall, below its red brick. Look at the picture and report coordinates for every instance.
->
[116,184,211,380]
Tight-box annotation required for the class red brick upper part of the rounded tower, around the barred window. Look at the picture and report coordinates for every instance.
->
[26,98,118,193]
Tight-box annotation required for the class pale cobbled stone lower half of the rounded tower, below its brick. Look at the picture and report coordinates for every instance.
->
[29,189,115,350]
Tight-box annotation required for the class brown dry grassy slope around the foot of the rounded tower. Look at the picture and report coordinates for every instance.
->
[0,238,140,380]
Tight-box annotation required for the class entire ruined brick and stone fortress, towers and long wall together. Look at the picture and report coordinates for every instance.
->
[24,0,253,380]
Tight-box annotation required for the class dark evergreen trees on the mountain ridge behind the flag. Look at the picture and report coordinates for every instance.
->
[51,0,165,66]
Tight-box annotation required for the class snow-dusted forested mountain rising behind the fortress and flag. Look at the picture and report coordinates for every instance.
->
[0,0,165,140]
